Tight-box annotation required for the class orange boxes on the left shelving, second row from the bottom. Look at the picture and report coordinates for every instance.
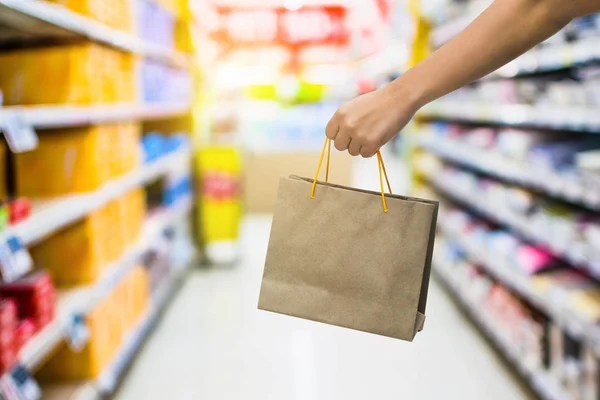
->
[30,206,113,287]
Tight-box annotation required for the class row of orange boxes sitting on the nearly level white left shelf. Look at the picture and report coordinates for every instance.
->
[0,43,136,105]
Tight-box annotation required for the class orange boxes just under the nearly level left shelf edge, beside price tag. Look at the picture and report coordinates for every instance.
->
[15,125,113,198]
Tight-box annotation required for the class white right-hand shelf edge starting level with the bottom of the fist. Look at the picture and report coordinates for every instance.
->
[421,134,600,211]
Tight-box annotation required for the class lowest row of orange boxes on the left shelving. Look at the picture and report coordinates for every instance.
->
[38,266,149,383]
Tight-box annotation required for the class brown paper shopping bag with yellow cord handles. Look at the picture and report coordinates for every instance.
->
[258,140,438,341]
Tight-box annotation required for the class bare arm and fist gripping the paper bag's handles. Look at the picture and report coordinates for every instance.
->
[326,0,600,157]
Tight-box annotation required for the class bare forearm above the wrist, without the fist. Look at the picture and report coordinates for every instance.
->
[391,0,584,109]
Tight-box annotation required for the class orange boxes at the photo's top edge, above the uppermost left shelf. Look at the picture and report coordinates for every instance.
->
[46,0,133,32]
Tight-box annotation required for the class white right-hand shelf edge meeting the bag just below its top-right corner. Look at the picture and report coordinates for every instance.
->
[439,219,600,349]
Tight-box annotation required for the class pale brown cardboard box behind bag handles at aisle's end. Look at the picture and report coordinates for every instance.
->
[243,149,353,213]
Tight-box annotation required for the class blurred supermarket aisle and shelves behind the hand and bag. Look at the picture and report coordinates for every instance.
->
[0,0,600,400]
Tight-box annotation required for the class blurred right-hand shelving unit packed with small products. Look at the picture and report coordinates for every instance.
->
[411,1,600,400]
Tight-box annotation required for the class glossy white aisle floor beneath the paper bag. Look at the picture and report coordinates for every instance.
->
[117,217,529,400]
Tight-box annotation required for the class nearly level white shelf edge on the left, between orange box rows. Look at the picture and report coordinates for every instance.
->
[0,101,191,129]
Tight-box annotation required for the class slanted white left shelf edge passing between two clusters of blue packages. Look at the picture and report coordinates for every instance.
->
[9,149,191,244]
